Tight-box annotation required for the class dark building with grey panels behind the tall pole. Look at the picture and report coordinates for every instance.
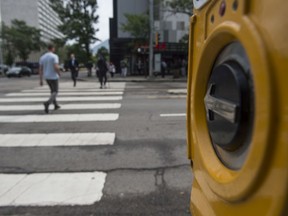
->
[110,0,192,74]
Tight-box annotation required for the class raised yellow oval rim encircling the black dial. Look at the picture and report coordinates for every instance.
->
[192,17,272,201]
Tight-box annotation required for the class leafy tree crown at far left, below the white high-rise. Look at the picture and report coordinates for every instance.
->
[1,19,43,63]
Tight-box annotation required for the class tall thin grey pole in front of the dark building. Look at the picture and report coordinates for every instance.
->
[149,0,154,77]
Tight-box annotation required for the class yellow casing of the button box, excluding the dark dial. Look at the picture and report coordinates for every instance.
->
[187,0,288,216]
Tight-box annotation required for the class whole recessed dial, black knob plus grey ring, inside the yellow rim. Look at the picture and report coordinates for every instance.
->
[204,41,255,170]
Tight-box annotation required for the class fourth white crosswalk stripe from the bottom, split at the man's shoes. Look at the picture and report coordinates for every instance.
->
[0,103,121,111]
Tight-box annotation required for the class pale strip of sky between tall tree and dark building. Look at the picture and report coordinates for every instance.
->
[94,0,113,45]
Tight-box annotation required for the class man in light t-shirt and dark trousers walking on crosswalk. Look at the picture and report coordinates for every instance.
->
[39,44,60,113]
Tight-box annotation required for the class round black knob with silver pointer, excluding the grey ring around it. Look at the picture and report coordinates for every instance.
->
[205,61,249,151]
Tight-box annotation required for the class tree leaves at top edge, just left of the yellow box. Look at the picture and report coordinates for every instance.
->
[166,0,193,16]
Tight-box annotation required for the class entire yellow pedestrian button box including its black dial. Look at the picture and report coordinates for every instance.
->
[187,0,288,216]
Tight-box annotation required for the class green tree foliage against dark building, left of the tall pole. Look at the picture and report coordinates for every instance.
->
[121,13,150,40]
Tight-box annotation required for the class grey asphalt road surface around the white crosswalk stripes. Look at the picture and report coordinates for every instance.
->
[0,75,192,216]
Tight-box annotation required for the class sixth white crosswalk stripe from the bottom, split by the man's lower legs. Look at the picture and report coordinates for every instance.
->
[5,92,123,97]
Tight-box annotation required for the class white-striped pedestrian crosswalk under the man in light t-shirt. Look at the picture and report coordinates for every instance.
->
[0,82,125,207]
